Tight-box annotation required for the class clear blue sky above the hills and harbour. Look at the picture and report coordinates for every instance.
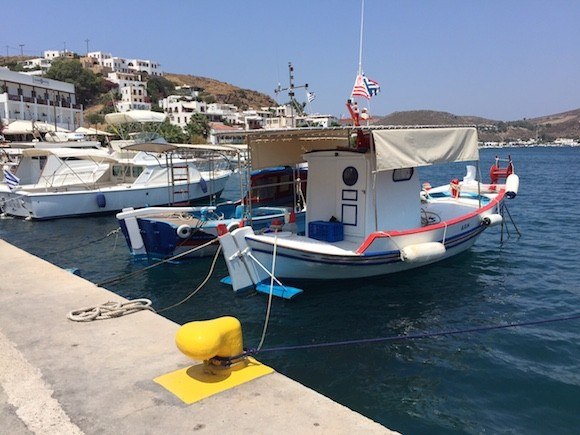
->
[0,0,580,121]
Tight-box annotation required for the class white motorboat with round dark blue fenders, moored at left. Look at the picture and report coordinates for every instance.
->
[0,143,232,219]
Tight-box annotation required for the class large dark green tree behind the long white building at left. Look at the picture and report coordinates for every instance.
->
[46,59,101,106]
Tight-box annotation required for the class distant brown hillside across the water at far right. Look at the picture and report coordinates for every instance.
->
[372,109,580,142]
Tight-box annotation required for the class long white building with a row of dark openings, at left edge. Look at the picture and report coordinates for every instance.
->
[0,68,83,130]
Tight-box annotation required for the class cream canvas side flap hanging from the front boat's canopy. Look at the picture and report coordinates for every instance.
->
[373,127,479,171]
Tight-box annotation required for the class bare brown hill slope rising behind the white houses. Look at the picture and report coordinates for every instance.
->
[164,73,276,110]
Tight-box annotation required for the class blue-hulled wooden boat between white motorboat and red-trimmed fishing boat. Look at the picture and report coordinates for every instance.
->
[117,166,308,259]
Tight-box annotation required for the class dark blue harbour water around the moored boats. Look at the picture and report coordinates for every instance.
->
[0,147,580,434]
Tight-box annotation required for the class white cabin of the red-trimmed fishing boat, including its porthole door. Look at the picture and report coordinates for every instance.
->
[304,151,421,244]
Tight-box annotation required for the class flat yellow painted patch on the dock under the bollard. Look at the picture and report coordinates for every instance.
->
[154,357,274,405]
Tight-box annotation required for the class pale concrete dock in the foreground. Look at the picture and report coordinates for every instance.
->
[0,240,393,434]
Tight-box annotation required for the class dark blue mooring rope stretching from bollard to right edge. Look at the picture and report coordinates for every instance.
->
[246,314,580,355]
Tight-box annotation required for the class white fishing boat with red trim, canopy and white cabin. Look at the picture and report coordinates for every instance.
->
[219,125,519,298]
